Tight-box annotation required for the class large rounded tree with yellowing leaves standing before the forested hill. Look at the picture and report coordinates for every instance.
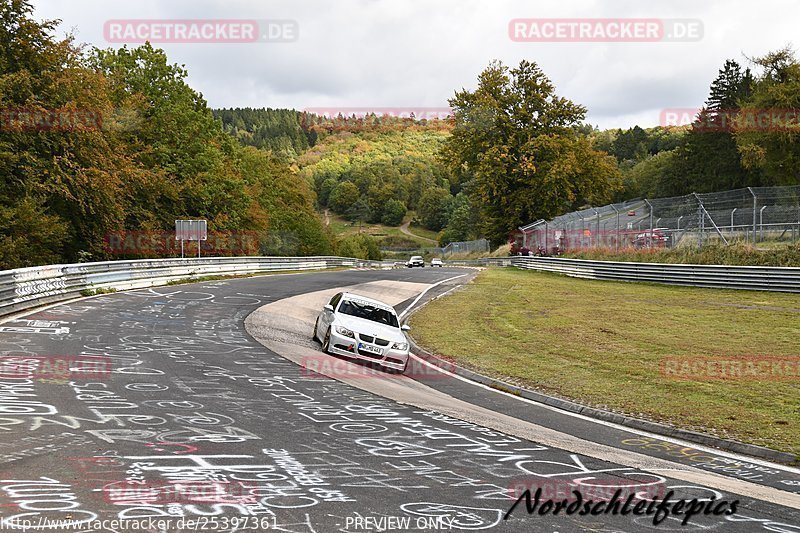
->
[443,61,620,243]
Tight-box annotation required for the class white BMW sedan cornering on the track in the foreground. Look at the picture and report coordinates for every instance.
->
[314,292,411,372]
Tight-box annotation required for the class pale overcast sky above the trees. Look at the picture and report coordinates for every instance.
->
[34,0,800,128]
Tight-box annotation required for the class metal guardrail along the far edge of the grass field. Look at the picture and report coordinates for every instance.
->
[510,257,800,292]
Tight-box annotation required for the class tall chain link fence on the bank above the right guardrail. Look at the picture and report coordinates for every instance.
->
[518,185,800,254]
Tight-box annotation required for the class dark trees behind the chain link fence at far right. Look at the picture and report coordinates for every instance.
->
[592,48,800,200]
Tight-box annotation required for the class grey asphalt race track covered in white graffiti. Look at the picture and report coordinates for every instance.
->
[0,268,800,533]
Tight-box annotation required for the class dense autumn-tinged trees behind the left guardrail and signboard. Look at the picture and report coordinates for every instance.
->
[0,0,334,269]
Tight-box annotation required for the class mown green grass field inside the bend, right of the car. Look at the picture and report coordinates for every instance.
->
[411,268,800,454]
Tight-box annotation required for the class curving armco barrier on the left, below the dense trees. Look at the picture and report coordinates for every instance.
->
[0,257,384,317]
